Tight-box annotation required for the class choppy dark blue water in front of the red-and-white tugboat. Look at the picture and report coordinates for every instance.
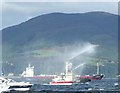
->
[8,79,120,93]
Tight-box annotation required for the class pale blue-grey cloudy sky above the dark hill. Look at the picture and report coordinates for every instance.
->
[0,0,118,29]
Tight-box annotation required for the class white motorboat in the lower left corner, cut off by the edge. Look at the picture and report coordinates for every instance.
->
[0,77,33,92]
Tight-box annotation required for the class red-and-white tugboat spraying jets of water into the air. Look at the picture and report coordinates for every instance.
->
[50,62,91,85]
